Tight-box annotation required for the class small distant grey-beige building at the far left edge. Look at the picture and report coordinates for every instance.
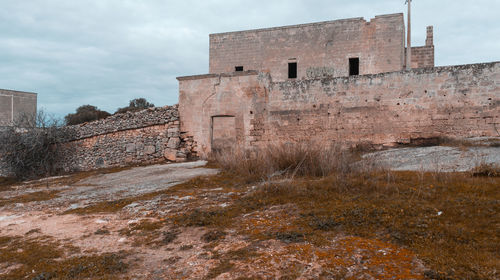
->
[0,89,37,126]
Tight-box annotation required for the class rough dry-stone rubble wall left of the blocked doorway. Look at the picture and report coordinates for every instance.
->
[0,105,196,176]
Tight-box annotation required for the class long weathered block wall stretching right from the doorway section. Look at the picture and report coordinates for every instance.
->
[255,63,500,145]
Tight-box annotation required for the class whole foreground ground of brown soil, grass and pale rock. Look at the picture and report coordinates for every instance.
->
[0,161,500,279]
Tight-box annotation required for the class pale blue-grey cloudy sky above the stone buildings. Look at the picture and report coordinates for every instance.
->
[0,0,500,117]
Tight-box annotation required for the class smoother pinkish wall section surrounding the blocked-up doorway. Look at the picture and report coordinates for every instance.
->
[178,71,267,155]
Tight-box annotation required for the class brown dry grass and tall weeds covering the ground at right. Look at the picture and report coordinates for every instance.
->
[174,144,500,279]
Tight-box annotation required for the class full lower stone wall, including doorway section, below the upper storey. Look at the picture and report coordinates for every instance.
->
[178,62,500,156]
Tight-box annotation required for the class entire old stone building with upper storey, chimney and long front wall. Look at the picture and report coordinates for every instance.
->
[177,14,500,156]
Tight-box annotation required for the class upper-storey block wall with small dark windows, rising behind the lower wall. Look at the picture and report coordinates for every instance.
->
[209,14,405,81]
